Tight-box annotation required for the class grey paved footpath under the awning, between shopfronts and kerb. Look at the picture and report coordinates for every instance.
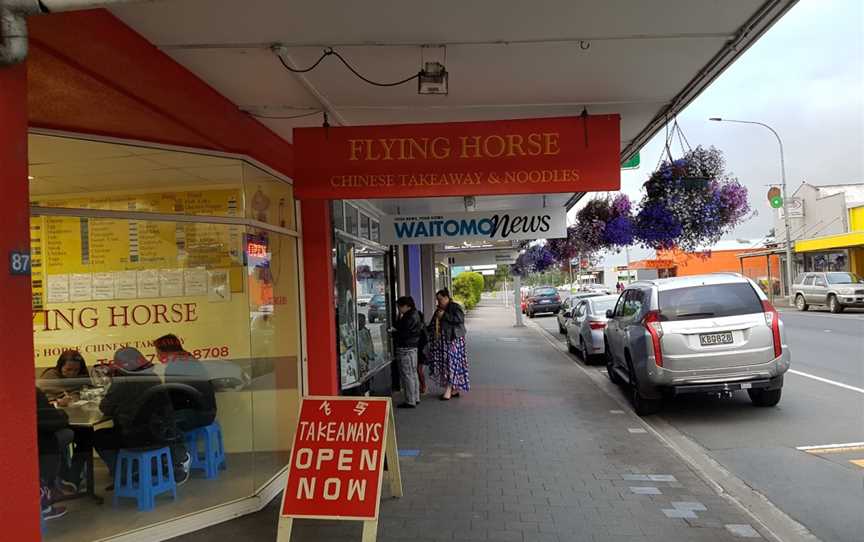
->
[175,302,769,542]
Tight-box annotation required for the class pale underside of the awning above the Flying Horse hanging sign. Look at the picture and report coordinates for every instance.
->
[106,0,796,212]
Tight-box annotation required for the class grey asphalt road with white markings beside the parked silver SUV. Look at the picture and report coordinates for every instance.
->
[534,309,864,542]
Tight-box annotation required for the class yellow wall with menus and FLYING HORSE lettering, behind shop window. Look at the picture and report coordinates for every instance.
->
[30,190,250,366]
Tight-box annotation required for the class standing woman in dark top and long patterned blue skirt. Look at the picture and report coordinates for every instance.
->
[429,288,470,401]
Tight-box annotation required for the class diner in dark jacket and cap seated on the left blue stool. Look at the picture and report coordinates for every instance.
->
[94,348,191,485]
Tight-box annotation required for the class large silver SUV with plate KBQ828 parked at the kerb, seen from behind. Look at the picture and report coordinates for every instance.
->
[605,273,791,416]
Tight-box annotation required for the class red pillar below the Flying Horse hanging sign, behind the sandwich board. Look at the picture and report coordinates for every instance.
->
[300,200,339,395]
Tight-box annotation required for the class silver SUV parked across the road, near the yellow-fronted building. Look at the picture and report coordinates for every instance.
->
[792,271,864,313]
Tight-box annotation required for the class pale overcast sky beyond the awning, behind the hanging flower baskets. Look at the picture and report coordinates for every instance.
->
[586,0,864,265]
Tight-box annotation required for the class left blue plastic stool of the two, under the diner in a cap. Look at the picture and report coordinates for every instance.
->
[114,447,177,512]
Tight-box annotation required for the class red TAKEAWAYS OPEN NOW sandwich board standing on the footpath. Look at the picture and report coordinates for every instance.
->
[276,397,402,542]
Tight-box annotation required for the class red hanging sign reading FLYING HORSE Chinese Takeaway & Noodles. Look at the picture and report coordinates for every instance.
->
[294,115,621,199]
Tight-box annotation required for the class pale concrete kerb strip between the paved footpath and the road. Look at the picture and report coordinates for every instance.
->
[527,320,821,542]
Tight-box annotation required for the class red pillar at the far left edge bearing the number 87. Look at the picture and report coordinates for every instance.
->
[0,64,40,540]
